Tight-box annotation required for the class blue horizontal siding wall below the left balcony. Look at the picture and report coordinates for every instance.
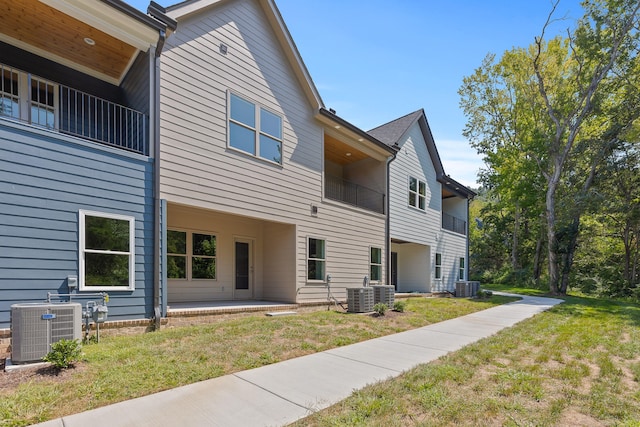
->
[0,121,153,329]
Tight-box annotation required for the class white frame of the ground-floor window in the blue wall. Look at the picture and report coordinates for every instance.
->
[78,209,136,291]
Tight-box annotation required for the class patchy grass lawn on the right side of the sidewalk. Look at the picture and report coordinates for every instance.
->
[296,289,640,426]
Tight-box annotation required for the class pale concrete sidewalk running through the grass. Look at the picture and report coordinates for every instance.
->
[32,293,562,427]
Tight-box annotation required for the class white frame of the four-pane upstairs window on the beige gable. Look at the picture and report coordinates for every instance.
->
[227,90,284,166]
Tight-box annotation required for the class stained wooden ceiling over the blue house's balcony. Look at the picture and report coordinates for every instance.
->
[0,0,152,84]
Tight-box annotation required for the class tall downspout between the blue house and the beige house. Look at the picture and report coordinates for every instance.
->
[153,30,166,330]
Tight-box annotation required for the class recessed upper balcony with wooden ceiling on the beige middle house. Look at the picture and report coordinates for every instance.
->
[317,109,395,214]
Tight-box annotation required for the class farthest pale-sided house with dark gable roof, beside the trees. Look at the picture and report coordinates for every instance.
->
[369,110,475,292]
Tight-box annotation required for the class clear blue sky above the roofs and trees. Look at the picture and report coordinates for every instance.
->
[126,0,582,187]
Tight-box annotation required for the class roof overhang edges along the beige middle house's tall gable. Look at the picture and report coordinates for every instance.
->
[166,0,324,110]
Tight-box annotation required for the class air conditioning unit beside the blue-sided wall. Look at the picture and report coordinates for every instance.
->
[11,303,82,364]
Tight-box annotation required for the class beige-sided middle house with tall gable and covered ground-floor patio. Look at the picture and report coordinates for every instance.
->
[160,0,394,308]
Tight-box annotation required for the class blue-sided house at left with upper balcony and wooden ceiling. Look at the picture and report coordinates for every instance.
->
[0,0,171,332]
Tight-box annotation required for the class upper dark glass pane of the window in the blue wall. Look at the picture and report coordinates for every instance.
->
[85,215,129,252]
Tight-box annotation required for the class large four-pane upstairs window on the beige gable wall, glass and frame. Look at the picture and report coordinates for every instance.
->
[229,93,282,164]
